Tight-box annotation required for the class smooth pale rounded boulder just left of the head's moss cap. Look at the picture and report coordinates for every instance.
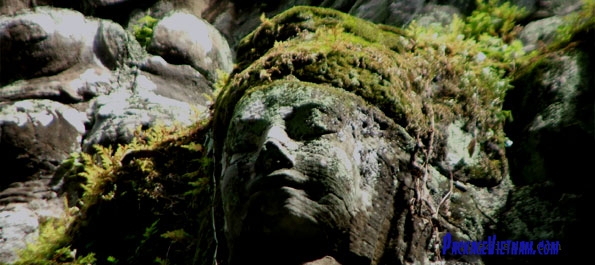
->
[147,12,233,82]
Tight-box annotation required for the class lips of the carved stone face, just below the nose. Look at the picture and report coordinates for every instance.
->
[247,169,308,194]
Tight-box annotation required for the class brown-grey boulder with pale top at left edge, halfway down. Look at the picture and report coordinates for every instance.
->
[0,100,87,187]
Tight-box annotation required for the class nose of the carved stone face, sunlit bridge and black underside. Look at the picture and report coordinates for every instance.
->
[256,127,295,174]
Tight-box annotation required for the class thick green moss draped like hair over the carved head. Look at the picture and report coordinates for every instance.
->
[215,7,522,188]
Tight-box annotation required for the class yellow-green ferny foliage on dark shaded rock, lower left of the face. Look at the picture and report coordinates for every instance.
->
[16,118,214,265]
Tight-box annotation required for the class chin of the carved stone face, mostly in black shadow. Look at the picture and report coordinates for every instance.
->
[226,186,329,264]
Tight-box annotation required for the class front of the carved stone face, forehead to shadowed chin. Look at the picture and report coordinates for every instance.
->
[220,81,400,263]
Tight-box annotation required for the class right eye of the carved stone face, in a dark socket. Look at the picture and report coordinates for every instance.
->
[285,104,342,140]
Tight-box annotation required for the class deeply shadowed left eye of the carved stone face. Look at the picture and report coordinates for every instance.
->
[225,118,268,153]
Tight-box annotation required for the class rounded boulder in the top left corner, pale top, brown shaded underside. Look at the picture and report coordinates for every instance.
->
[0,8,91,85]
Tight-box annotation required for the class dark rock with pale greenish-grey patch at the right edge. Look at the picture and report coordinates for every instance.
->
[507,51,595,186]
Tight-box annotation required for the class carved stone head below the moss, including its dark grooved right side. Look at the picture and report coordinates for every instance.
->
[220,81,411,264]
